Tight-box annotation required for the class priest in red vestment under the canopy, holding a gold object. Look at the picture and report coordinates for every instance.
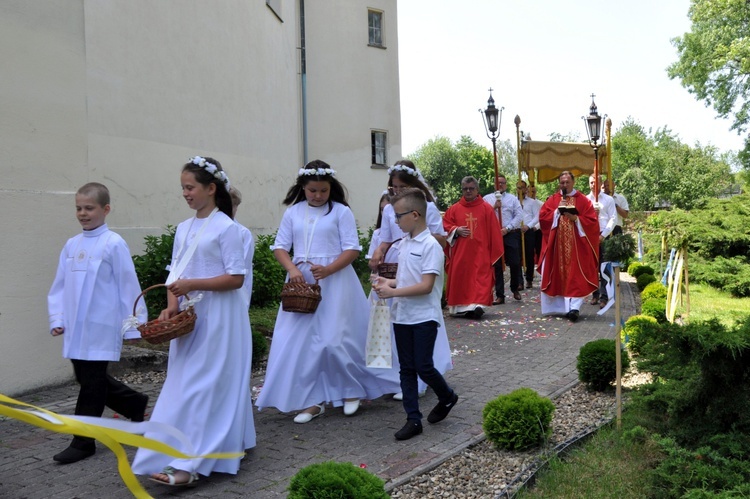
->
[539,172,599,322]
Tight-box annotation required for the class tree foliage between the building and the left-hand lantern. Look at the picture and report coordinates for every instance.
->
[409,135,517,210]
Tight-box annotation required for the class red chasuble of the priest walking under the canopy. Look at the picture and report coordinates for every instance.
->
[539,191,599,298]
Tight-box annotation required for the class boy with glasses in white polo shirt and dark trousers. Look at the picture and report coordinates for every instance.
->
[373,189,458,440]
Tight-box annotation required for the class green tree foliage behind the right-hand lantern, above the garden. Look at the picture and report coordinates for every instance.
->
[612,117,732,211]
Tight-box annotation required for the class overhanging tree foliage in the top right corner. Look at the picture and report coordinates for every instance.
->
[667,0,750,168]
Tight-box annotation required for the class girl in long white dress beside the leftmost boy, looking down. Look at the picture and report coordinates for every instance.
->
[133,156,255,485]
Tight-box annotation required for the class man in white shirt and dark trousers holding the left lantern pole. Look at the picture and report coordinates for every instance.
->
[483,175,523,305]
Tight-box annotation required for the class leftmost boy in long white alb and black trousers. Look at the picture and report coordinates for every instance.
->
[47,182,148,464]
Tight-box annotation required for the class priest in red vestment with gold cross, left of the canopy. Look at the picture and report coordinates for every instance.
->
[443,177,503,319]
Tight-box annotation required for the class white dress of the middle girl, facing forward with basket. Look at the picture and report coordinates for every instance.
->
[255,201,400,412]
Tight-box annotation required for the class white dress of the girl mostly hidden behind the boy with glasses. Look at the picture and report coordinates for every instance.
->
[378,202,453,392]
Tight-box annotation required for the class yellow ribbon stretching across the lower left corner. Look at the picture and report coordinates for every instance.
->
[0,394,244,499]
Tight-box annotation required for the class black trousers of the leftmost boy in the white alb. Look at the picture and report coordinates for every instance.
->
[70,359,147,450]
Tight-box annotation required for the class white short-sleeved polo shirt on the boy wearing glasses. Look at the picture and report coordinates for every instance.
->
[391,229,445,324]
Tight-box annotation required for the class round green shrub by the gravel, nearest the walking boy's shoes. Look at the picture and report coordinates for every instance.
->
[482,388,555,450]
